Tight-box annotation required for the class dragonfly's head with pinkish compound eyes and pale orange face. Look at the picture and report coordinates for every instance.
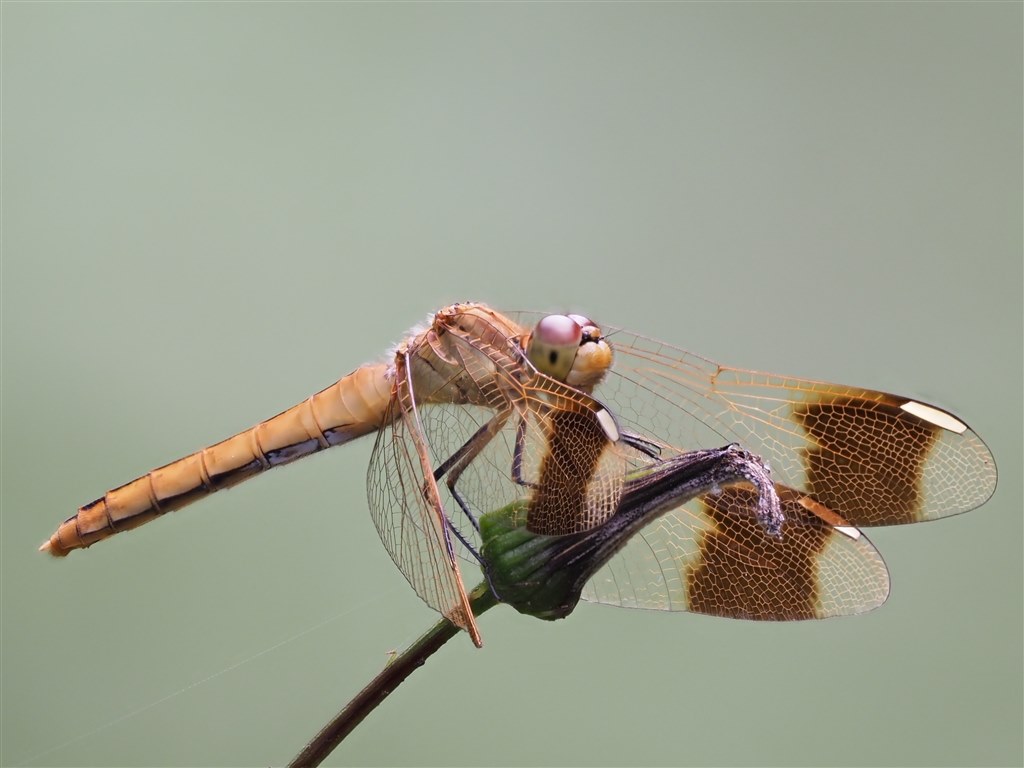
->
[526,314,611,390]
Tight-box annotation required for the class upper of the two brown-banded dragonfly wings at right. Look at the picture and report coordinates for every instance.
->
[599,332,996,525]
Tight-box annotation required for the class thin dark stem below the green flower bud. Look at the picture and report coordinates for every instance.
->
[289,582,498,768]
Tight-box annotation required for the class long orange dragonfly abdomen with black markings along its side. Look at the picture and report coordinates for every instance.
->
[40,364,391,557]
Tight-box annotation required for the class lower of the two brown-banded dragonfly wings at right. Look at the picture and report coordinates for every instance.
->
[583,484,889,621]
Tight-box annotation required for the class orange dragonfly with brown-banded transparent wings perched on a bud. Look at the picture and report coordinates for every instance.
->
[40,302,996,646]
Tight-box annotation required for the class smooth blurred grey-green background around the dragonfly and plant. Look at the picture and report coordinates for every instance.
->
[0,2,1024,766]
